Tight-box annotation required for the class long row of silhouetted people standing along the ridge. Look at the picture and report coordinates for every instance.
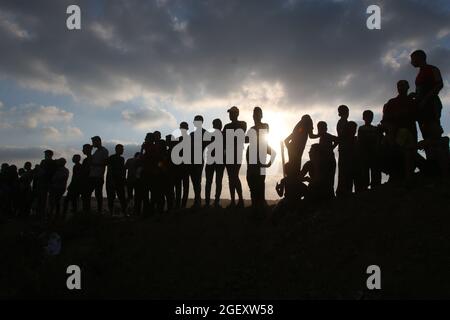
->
[0,50,450,220]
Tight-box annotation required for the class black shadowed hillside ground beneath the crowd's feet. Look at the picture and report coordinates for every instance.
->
[0,175,450,299]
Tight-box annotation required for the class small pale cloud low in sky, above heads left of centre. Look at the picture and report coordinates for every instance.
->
[122,107,176,129]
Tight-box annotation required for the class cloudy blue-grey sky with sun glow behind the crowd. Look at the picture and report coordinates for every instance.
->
[0,0,450,197]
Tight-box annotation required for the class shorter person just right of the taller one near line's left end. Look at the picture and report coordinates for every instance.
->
[49,158,69,219]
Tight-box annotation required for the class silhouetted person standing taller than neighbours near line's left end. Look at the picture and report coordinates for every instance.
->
[37,150,56,218]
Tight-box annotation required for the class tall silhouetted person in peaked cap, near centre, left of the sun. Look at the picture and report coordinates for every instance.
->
[223,106,247,207]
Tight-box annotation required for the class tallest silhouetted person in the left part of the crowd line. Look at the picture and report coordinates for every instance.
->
[89,136,108,213]
